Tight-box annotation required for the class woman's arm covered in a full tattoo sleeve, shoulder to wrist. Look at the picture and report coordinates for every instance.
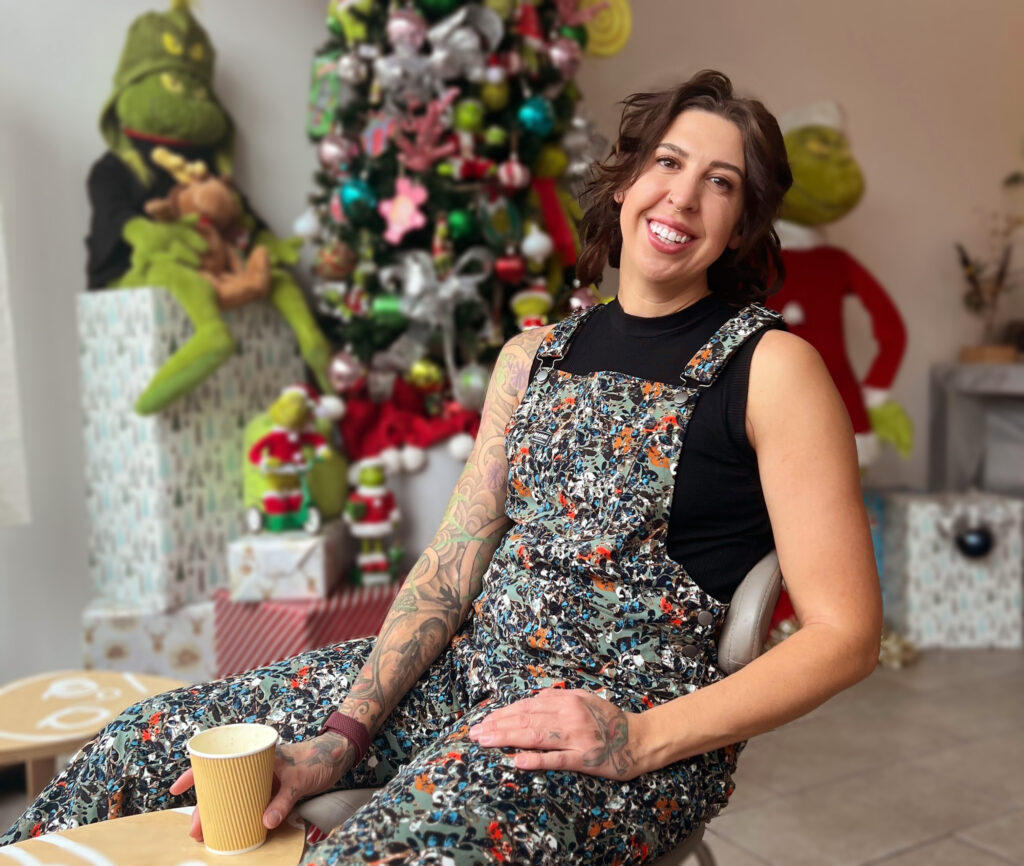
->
[340,329,545,732]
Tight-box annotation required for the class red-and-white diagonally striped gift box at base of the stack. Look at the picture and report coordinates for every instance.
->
[213,583,400,677]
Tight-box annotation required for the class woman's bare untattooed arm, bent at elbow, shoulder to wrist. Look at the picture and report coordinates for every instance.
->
[630,331,882,771]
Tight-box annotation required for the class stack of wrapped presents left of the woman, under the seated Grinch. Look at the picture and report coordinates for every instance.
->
[78,289,397,682]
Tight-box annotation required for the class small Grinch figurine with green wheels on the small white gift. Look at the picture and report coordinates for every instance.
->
[246,385,342,534]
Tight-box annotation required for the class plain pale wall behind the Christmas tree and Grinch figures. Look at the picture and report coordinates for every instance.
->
[0,0,1024,682]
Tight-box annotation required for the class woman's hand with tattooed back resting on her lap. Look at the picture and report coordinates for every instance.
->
[469,689,644,781]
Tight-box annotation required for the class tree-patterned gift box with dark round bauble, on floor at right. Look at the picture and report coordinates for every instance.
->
[883,493,1024,648]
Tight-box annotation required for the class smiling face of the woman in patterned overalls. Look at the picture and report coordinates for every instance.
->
[615,109,745,292]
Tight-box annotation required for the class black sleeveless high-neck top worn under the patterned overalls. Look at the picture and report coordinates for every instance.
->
[534,295,774,602]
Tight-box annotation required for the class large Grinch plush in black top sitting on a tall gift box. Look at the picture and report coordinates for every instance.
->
[86,0,331,415]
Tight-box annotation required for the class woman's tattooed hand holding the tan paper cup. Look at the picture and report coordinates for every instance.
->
[170,732,355,841]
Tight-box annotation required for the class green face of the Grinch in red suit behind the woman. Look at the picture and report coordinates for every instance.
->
[779,126,864,225]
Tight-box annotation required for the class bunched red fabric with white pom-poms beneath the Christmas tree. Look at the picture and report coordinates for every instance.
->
[338,378,480,461]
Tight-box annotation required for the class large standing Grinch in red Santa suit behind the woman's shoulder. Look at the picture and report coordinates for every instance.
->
[768,102,913,468]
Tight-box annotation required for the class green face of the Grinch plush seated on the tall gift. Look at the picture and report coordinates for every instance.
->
[117,71,227,144]
